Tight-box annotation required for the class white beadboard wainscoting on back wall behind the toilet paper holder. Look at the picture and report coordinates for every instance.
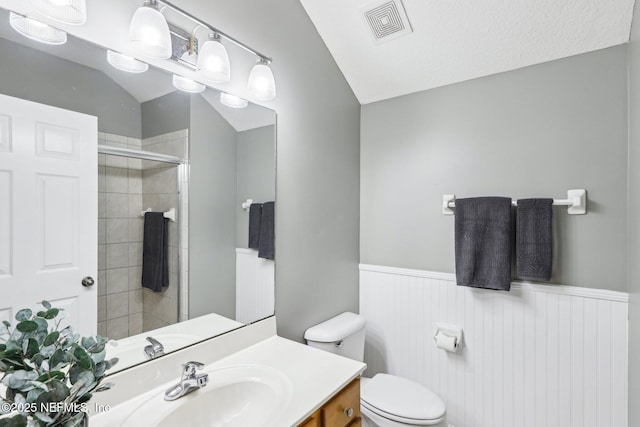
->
[360,265,628,427]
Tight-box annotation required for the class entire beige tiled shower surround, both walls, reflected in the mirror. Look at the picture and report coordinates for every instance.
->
[98,130,188,339]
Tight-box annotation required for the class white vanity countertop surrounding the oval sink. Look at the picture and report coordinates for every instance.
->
[90,320,366,427]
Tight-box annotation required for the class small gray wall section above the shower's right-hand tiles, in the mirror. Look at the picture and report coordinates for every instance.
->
[142,90,189,138]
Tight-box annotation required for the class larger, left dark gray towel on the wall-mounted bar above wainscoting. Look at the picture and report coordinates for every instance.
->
[455,197,511,291]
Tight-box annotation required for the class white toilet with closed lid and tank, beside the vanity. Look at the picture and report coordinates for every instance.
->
[304,312,447,427]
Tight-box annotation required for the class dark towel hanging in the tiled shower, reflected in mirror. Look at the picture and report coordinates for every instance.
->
[142,212,169,292]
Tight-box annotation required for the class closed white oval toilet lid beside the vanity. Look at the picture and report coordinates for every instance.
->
[360,374,445,424]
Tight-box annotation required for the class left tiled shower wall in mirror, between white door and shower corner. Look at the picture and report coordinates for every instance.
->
[98,132,143,339]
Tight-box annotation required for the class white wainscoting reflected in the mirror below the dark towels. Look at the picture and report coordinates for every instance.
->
[236,248,275,323]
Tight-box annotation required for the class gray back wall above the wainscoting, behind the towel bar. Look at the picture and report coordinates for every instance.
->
[360,46,627,291]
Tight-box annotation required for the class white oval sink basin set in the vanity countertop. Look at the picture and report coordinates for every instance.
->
[122,365,292,427]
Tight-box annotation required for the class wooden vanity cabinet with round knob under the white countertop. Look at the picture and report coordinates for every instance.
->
[300,378,362,427]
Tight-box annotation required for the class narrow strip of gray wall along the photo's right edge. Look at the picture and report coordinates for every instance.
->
[628,5,640,426]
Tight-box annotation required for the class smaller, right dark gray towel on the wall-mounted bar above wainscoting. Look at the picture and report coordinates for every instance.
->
[516,199,553,282]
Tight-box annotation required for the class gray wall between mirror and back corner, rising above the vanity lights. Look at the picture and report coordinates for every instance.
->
[181,0,360,341]
